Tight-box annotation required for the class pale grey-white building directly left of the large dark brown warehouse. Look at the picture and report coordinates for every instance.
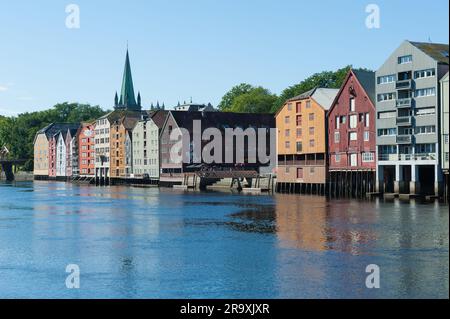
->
[133,110,168,179]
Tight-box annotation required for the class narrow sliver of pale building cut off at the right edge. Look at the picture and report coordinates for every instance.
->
[441,72,450,199]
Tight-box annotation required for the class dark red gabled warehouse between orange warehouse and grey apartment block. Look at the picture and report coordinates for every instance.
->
[327,70,376,196]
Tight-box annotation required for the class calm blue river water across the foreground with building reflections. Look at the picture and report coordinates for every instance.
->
[0,182,449,298]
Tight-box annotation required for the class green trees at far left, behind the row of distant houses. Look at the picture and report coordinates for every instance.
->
[0,102,106,170]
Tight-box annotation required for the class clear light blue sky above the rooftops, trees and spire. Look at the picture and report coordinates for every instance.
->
[0,0,449,115]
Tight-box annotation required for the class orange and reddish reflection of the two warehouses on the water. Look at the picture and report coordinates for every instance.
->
[276,195,377,255]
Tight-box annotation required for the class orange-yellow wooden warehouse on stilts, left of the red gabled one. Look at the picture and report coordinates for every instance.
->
[276,88,339,194]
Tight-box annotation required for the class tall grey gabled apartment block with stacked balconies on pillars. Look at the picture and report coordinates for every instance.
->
[376,41,449,195]
